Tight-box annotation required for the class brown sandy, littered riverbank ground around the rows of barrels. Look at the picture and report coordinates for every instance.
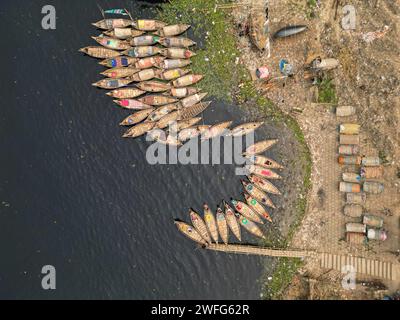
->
[233,0,400,299]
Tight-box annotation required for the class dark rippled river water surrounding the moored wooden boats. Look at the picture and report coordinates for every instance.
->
[0,0,282,299]
